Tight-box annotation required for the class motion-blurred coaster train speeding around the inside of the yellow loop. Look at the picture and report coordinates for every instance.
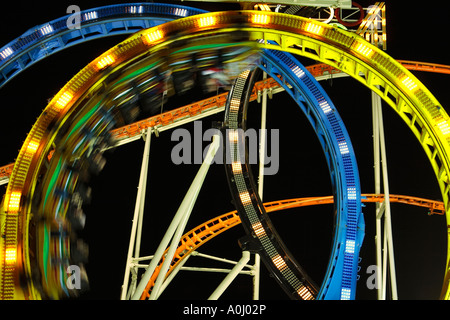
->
[5,36,260,298]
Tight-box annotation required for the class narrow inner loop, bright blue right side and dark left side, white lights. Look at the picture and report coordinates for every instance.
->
[225,50,364,299]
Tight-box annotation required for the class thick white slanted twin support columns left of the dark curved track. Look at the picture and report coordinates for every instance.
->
[131,134,220,300]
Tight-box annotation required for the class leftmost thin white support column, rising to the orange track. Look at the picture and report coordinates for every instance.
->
[120,128,152,300]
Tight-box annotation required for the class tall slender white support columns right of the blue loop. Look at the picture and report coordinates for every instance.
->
[372,92,398,300]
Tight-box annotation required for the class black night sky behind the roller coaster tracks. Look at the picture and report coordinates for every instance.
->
[0,1,450,299]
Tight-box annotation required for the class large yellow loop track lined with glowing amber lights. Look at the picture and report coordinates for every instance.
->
[3,8,449,297]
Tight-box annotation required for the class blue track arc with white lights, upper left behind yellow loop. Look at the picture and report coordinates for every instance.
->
[0,3,206,87]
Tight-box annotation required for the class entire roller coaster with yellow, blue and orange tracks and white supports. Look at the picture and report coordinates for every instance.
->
[0,0,450,300]
